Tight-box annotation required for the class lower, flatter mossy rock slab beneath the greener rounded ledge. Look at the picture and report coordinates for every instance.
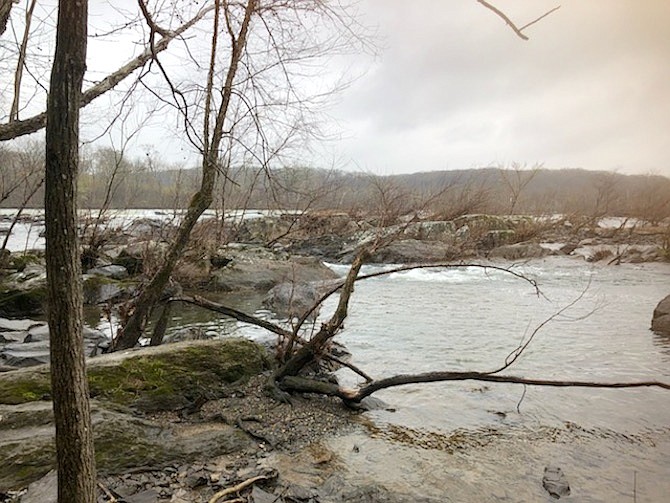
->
[0,401,250,493]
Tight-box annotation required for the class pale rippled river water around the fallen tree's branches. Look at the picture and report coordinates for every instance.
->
[213,257,670,503]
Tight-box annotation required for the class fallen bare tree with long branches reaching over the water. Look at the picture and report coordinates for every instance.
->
[152,248,670,406]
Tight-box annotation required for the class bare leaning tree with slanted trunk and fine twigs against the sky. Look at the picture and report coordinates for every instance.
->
[114,0,370,349]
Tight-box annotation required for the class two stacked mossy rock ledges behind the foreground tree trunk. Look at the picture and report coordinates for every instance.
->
[0,339,268,493]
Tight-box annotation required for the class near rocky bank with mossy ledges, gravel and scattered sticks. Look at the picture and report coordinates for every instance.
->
[0,341,402,503]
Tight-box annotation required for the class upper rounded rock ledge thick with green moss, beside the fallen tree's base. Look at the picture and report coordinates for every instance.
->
[0,339,270,412]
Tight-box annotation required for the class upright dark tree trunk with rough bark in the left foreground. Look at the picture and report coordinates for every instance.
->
[44,0,96,503]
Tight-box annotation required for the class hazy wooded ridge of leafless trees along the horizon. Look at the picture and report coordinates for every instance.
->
[0,144,670,222]
